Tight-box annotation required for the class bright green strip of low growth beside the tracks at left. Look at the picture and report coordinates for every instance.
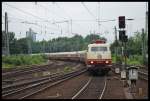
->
[2,55,48,68]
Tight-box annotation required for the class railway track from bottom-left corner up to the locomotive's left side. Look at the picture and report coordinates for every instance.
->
[3,64,86,99]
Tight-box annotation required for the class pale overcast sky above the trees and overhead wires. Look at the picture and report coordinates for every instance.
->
[2,2,148,43]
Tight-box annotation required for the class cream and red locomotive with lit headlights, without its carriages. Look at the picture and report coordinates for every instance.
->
[86,40,112,74]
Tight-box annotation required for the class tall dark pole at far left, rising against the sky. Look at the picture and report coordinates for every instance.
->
[5,12,10,55]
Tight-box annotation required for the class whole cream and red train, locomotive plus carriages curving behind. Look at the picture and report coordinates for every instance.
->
[46,40,112,74]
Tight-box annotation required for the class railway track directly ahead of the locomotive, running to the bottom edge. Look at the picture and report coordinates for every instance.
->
[72,77,107,99]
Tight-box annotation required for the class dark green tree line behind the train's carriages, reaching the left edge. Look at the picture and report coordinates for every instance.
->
[2,31,106,54]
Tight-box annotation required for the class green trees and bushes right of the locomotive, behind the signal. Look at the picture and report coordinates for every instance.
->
[111,32,148,64]
